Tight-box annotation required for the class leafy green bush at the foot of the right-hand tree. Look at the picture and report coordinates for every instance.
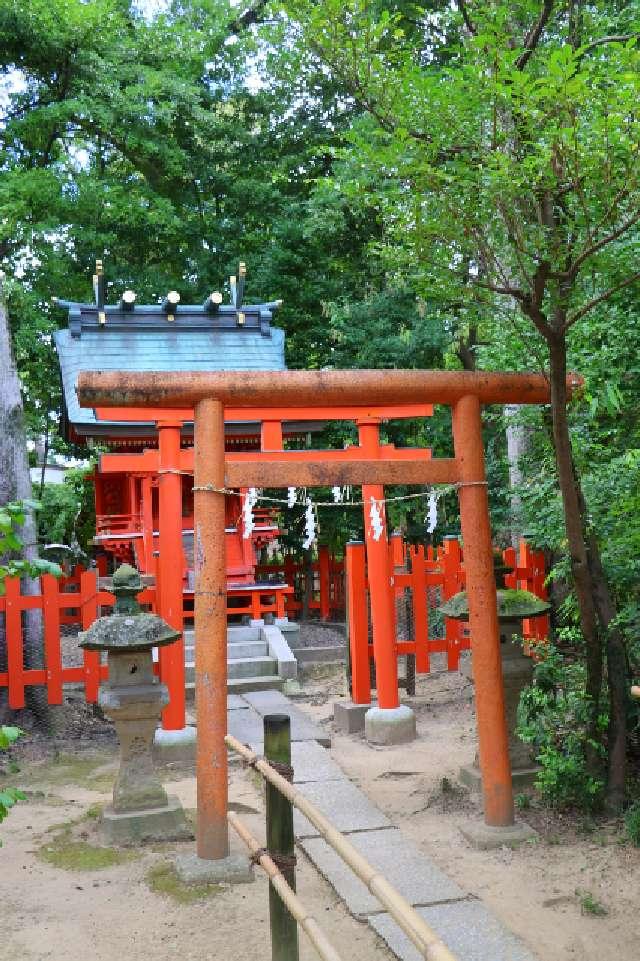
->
[518,646,608,810]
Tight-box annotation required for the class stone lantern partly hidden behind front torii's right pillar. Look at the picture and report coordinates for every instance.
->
[439,552,550,789]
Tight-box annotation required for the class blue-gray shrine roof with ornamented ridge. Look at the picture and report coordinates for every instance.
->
[54,305,285,435]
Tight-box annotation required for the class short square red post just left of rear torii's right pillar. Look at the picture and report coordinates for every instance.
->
[345,541,371,704]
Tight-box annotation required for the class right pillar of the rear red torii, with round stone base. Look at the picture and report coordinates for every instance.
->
[358,418,416,744]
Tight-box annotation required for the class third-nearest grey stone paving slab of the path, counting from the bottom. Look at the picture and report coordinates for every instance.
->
[293,779,391,838]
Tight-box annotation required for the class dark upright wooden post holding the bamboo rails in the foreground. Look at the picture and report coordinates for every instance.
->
[264,714,298,961]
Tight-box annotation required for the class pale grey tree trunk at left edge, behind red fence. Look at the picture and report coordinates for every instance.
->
[0,286,49,728]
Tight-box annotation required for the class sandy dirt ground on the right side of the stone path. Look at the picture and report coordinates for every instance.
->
[296,658,640,961]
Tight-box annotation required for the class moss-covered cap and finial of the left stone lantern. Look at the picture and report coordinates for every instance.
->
[79,564,180,654]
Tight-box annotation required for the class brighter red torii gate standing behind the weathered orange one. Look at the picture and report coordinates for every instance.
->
[95,404,433,730]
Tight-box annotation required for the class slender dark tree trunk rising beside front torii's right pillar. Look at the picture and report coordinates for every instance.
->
[549,333,627,810]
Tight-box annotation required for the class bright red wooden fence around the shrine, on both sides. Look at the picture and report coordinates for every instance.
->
[0,536,549,709]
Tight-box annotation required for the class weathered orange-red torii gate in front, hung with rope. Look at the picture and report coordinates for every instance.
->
[77,370,580,860]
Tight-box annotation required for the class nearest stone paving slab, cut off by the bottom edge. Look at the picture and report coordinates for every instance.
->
[367,900,539,961]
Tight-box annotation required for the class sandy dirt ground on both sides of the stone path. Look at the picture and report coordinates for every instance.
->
[0,648,640,961]
